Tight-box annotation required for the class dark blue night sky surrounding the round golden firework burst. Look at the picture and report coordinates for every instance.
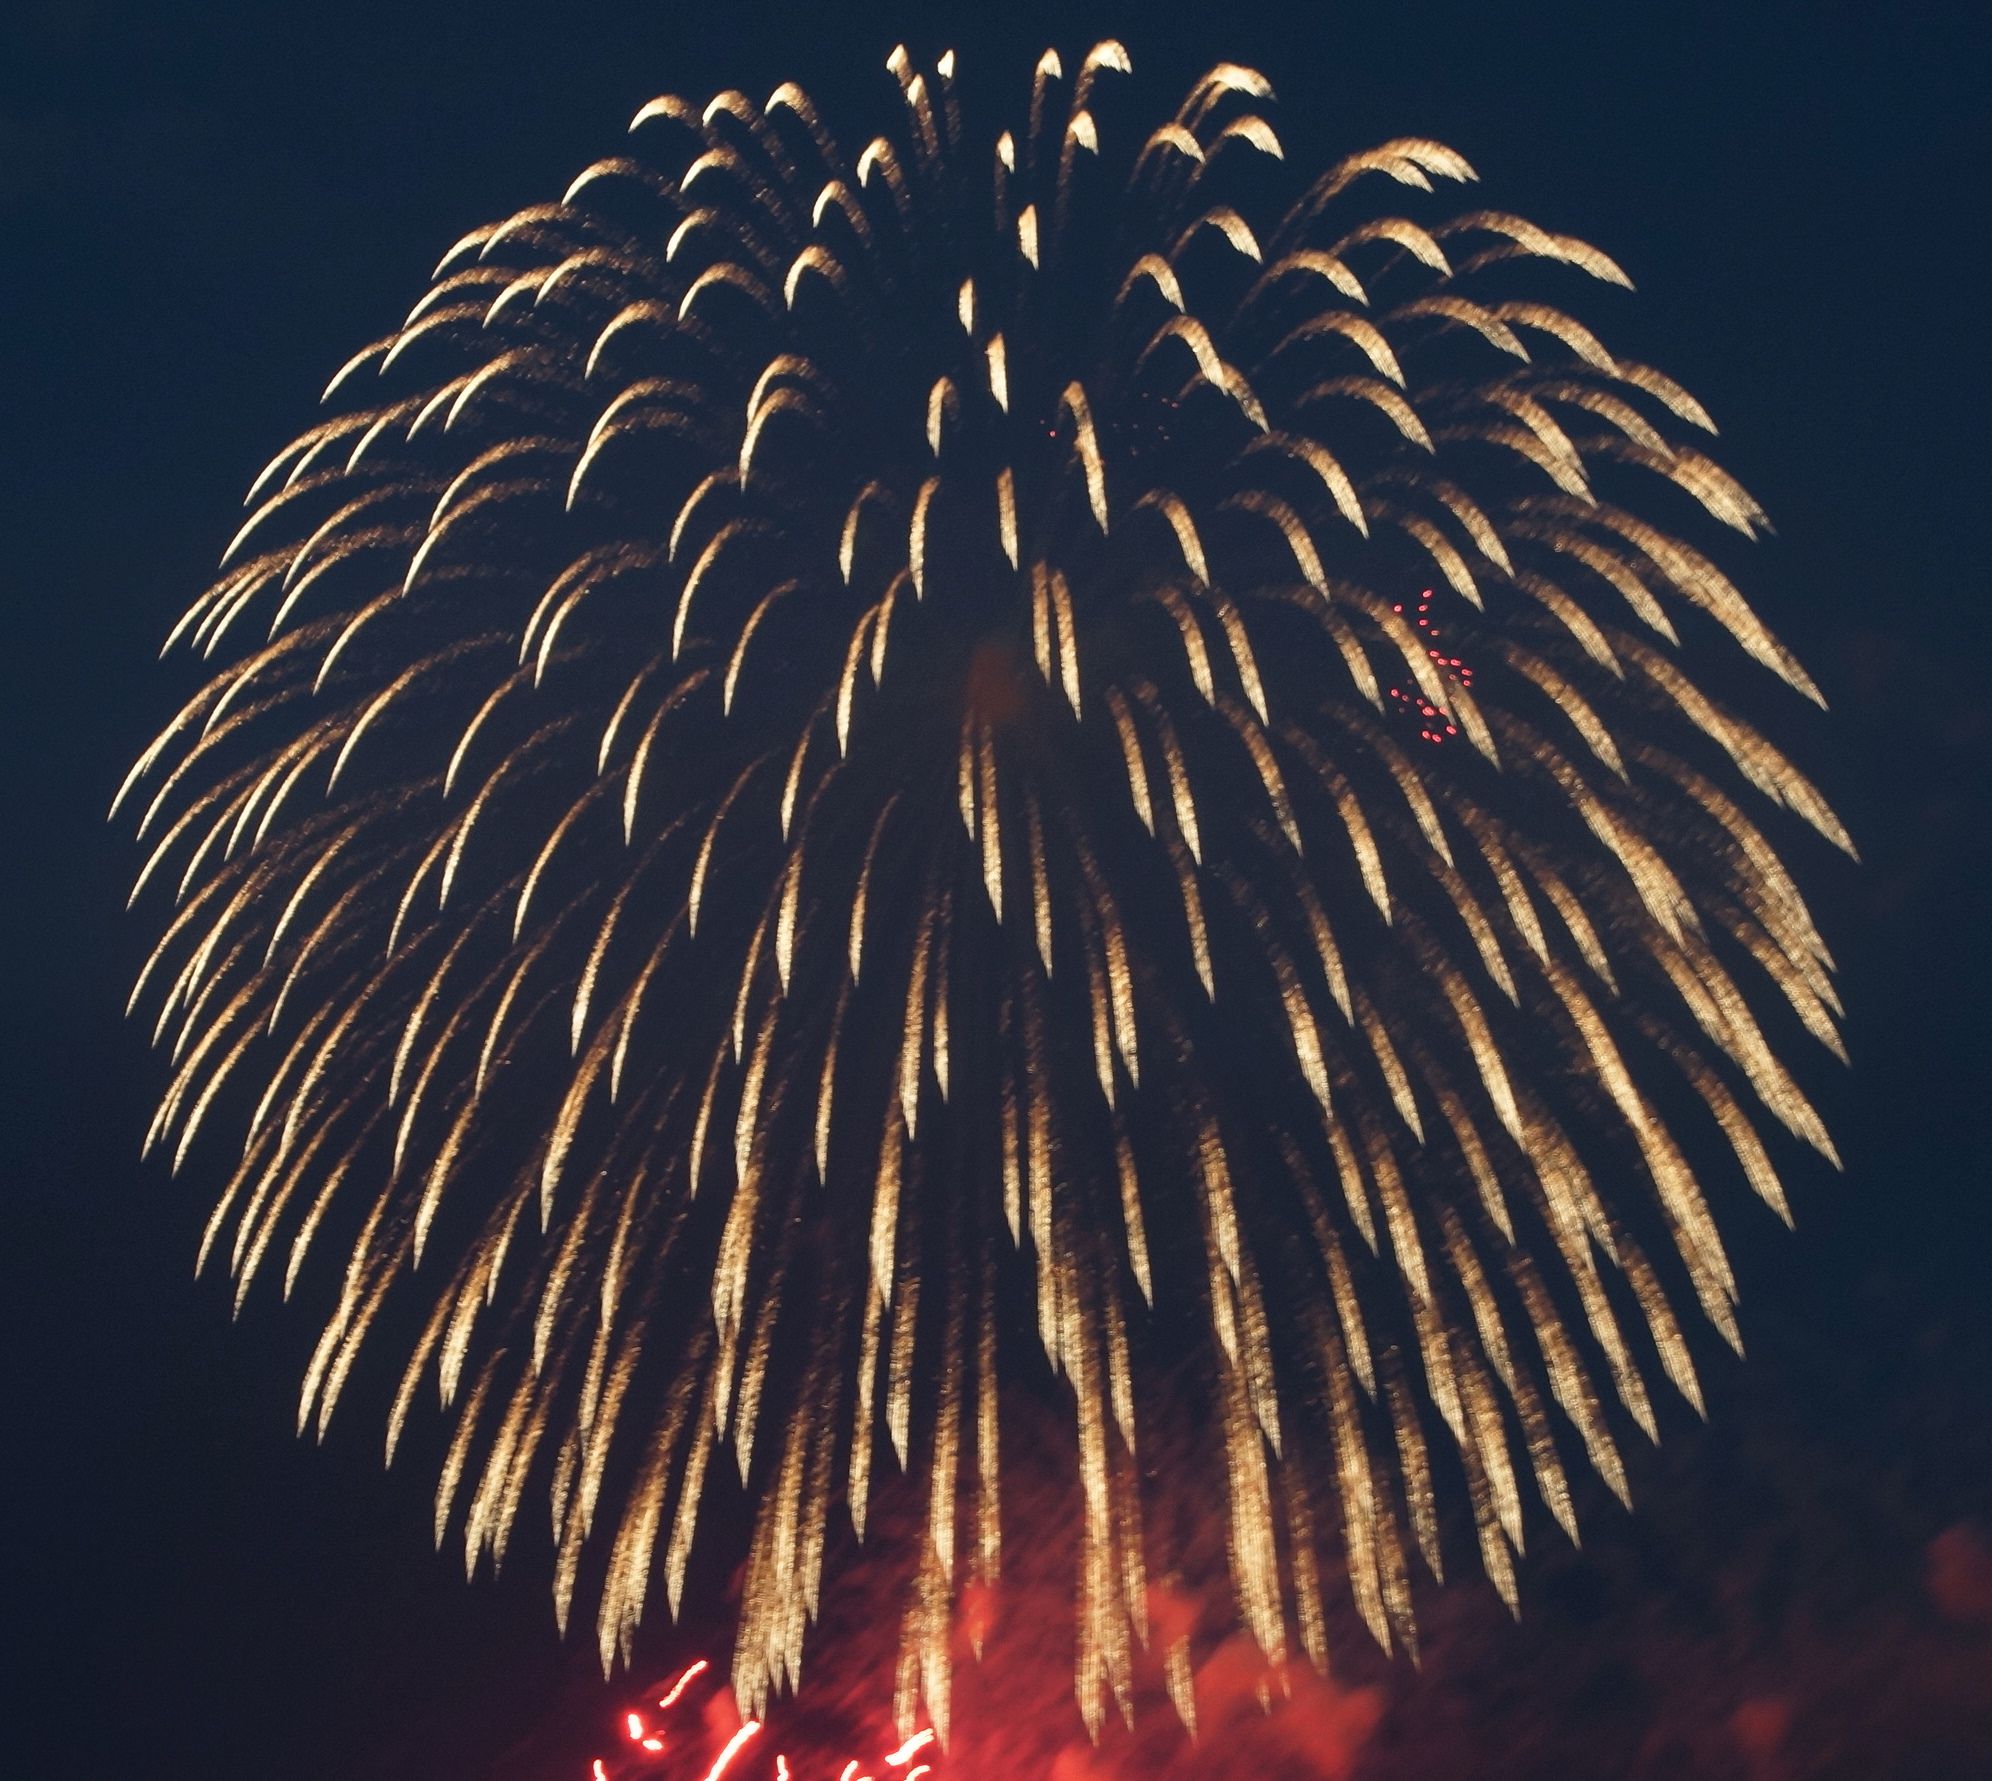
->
[0,0,1992,1781]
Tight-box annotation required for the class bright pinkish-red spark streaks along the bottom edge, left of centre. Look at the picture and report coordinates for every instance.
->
[588,1657,942,1781]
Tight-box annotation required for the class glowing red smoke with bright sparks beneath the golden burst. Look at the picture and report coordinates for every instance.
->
[577,1406,1386,1781]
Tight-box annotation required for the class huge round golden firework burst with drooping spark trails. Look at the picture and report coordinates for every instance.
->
[120,44,1851,1733]
